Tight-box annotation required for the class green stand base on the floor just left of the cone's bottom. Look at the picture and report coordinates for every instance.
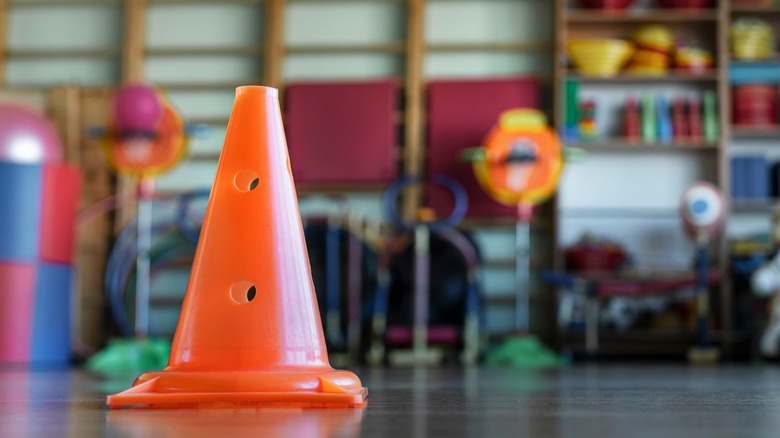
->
[86,339,171,377]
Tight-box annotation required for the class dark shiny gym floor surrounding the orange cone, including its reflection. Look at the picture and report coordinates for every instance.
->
[0,365,780,438]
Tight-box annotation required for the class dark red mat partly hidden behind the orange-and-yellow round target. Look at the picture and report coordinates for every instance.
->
[428,77,541,217]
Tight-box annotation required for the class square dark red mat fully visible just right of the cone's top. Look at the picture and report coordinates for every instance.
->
[285,80,398,184]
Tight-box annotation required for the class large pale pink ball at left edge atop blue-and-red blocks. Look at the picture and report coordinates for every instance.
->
[0,102,62,164]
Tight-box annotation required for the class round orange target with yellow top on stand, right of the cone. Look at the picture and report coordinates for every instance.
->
[466,109,563,206]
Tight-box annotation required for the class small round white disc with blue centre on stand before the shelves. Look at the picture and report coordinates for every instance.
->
[680,182,725,235]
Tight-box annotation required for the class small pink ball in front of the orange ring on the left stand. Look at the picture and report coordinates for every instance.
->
[114,83,162,133]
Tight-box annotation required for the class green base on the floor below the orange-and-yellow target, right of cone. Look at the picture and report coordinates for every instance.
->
[485,336,566,368]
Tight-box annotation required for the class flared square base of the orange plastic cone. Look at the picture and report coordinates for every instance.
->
[106,370,368,409]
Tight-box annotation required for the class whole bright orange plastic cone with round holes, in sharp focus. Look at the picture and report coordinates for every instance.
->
[107,86,367,408]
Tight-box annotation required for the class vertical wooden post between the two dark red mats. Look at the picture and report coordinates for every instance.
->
[403,0,425,219]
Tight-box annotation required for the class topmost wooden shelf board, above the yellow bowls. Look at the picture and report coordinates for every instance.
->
[564,9,718,23]
